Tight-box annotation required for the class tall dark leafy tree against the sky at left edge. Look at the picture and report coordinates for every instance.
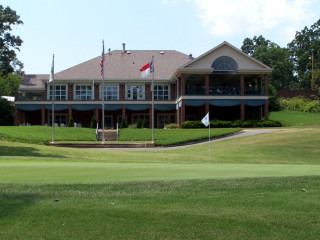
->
[0,5,23,76]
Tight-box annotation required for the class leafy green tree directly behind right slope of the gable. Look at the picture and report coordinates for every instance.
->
[241,36,297,89]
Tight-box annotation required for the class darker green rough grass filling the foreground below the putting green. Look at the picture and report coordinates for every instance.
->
[0,176,320,240]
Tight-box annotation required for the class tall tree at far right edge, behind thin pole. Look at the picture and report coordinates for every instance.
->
[288,19,320,89]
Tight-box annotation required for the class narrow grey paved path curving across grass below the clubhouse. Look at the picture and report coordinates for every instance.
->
[91,129,279,151]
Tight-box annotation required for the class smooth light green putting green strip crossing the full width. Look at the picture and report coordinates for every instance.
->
[0,162,320,184]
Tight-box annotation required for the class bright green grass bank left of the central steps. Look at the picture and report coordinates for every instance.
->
[0,126,96,145]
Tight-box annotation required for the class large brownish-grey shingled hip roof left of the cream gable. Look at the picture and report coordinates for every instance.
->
[55,50,190,80]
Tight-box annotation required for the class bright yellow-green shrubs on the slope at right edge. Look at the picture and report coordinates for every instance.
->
[280,97,320,113]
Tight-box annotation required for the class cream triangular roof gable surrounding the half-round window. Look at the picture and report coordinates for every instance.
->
[180,42,272,72]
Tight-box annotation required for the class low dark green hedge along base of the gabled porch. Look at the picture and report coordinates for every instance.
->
[181,119,282,129]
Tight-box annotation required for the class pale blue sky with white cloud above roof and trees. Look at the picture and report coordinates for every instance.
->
[0,0,320,74]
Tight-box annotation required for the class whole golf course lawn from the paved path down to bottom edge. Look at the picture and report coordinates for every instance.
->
[0,110,320,240]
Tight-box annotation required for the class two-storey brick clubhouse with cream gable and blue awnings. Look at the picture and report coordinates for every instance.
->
[14,42,272,128]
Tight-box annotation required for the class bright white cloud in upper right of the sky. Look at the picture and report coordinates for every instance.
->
[195,0,319,41]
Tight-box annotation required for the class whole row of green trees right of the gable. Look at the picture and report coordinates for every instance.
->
[241,19,320,90]
